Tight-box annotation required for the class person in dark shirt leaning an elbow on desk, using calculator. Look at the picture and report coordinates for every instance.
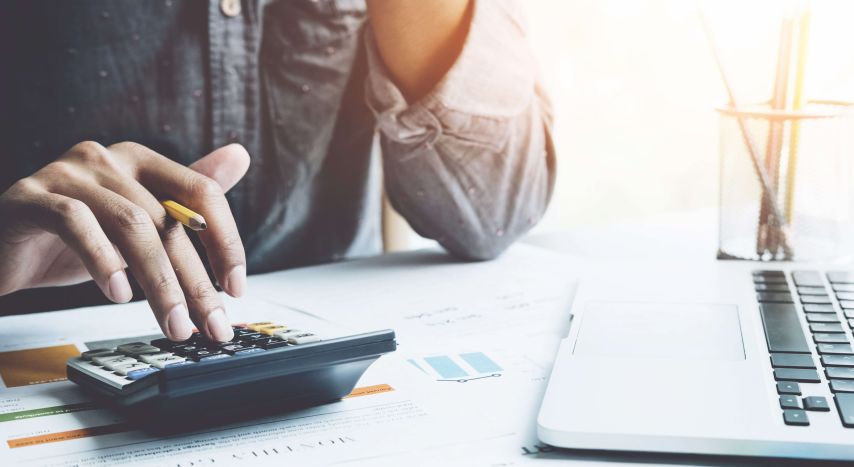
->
[0,0,555,341]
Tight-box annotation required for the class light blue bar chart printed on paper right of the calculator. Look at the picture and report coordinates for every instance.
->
[407,352,504,383]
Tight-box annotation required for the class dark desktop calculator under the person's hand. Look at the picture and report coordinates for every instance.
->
[67,322,397,428]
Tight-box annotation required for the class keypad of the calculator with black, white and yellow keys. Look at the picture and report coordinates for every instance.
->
[69,321,321,388]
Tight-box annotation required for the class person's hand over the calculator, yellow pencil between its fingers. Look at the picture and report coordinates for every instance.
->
[0,142,249,341]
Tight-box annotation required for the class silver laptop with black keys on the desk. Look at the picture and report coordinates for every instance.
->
[537,261,854,460]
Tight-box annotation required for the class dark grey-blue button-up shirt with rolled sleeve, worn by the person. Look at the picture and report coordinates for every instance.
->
[0,0,554,314]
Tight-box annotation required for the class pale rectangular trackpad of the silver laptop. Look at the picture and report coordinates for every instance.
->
[573,302,745,360]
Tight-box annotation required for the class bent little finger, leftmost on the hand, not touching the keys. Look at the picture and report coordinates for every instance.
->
[4,183,133,303]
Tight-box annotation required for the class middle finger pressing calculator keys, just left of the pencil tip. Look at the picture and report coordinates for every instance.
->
[104,177,234,342]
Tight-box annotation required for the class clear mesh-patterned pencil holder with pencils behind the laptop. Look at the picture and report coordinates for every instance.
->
[717,101,854,262]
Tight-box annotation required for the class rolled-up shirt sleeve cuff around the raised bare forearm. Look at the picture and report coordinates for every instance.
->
[365,0,536,144]
